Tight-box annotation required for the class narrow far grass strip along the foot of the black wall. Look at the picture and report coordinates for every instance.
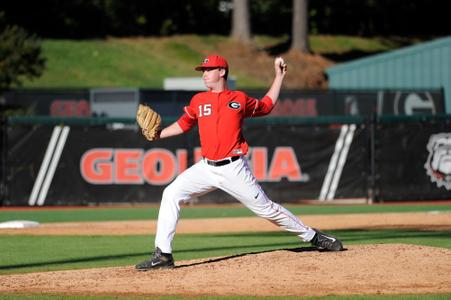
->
[0,203,451,223]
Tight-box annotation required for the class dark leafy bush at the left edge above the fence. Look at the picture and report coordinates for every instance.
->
[0,25,45,92]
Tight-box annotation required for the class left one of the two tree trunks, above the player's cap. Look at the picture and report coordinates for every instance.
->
[231,0,251,44]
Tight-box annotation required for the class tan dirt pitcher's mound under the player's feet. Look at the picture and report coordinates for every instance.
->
[0,244,451,296]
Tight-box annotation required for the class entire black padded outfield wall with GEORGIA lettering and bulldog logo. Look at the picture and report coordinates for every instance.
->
[2,115,451,206]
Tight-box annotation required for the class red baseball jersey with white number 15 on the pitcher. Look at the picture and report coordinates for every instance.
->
[177,90,274,160]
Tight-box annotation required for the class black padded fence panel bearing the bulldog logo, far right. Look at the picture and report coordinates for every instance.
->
[372,115,451,201]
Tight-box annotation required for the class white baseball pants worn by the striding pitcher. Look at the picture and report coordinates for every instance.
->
[155,156,315,253]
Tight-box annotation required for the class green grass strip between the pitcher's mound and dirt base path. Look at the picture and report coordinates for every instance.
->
[0,230,451,274]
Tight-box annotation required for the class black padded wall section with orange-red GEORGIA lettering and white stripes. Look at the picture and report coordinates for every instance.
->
[5,124,366,205]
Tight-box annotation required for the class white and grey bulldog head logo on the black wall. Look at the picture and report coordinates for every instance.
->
[424,133,451,190]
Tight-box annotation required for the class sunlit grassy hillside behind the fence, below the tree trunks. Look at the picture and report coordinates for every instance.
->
[23,35,414,89]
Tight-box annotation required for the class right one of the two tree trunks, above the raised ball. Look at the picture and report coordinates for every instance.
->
[291,0,311,53]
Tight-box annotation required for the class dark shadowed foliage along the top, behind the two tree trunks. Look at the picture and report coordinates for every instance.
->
[0,0,449,38]
